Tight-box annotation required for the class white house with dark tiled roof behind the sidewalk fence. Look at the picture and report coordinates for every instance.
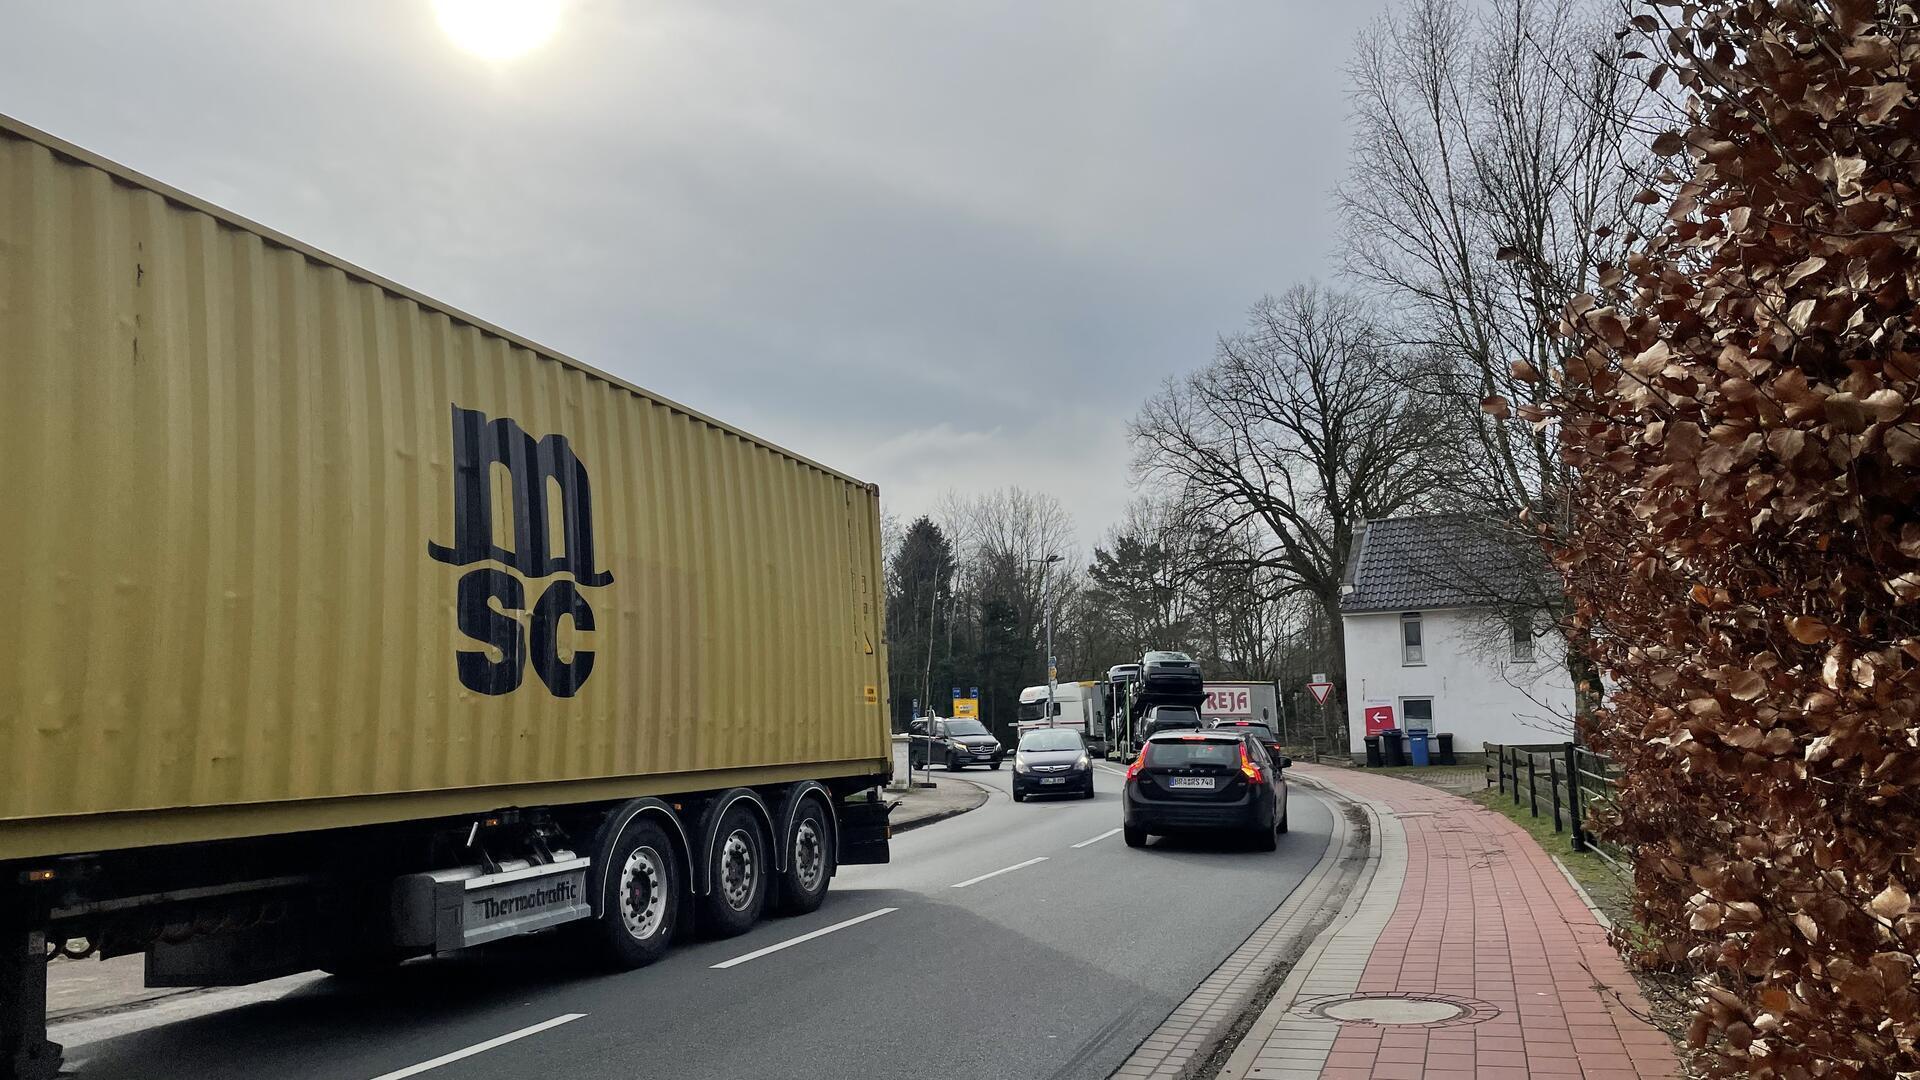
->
[1340,515,1574,755]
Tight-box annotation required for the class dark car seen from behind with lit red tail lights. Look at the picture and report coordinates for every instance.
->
[1121,728,1292,851]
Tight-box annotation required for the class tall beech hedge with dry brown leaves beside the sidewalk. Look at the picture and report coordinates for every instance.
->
[1528,0,1920,1076]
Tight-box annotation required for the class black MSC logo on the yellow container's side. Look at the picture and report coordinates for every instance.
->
[426,405,612,698]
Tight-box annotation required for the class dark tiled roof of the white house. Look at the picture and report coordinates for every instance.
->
[1340,515,1551,611]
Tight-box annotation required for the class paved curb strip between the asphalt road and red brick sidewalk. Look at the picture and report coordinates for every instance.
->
[1114,776,1379,1080]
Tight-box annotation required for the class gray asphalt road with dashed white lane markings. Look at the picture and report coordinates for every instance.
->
[56,753,1332,1080]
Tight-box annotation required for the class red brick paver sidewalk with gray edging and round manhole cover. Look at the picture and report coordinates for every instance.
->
[1223,765,1678,1080]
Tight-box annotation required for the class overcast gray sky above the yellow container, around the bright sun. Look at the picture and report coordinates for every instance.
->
[0,0,1382,544]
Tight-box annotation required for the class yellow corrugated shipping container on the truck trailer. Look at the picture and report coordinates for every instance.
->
[0,117,891,859]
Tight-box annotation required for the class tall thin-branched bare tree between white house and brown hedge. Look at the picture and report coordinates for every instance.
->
[1338,0,1655,714]
